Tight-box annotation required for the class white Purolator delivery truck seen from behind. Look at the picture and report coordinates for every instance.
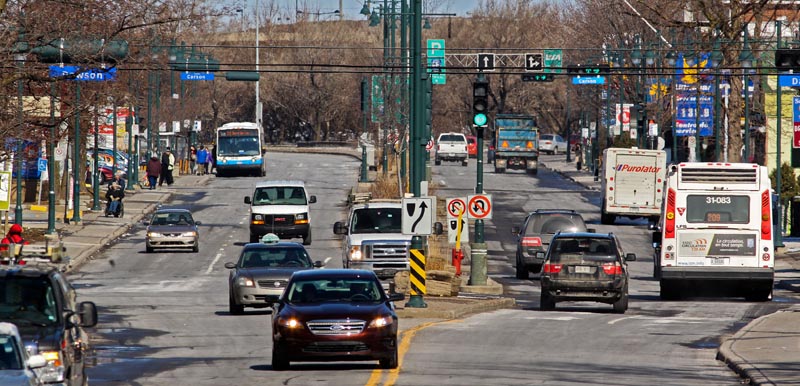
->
[600,148,667,224]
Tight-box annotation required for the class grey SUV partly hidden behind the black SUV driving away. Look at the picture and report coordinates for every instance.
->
[511,209,594,280]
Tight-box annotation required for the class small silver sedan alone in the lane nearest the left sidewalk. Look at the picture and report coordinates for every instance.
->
[144,209,200,253]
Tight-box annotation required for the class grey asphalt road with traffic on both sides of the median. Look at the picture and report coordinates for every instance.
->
[72,154,798,385]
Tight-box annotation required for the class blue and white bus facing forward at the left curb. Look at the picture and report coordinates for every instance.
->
[214,122,267,177]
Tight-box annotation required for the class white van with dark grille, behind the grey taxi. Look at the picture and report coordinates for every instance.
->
[244,181,317,245]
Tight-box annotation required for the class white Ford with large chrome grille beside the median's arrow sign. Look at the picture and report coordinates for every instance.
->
[333,200,412,279]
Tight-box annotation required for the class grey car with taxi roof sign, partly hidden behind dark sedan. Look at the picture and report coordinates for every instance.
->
[225,233,322,315]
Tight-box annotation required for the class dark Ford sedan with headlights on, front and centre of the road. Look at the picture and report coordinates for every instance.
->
[272,269,405,370]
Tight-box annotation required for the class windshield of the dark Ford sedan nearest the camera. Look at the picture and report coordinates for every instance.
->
[286,277,383,304]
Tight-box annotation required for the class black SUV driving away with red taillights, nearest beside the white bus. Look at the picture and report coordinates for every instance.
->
[538,233,636,313]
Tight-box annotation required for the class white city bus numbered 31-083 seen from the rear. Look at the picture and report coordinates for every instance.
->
[653,162,775,301]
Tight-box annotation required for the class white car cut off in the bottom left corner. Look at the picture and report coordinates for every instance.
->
[0,322,47,386]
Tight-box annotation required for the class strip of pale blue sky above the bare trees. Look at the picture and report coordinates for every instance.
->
[242,0,479,19]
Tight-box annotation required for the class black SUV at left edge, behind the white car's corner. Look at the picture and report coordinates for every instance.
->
[0,265,97,385]
